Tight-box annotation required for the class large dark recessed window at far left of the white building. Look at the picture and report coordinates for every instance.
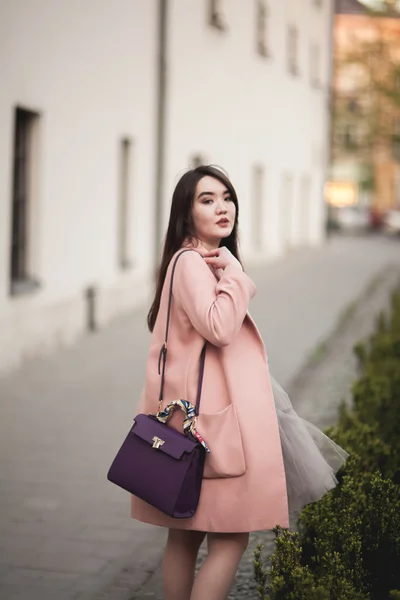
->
[10,108,39,295]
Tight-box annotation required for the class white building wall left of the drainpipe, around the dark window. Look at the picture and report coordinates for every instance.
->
[0,0,157,368]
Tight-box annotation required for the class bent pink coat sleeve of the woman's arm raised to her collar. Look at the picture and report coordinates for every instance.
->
[173,252,256,346]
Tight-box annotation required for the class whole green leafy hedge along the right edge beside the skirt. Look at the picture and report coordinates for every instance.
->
[255,293,400,600]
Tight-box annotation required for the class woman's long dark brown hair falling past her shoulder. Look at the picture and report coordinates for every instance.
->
[147,165,241,331]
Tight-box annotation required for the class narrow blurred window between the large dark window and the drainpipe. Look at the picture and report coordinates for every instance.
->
[117,138,132,269]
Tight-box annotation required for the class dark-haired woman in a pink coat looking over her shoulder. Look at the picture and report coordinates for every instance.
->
[131,166,346,600]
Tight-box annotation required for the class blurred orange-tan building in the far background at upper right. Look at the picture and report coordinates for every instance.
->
[327,0,400,227]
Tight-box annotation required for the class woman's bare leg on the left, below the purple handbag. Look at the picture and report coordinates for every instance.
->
[162,529,206,600]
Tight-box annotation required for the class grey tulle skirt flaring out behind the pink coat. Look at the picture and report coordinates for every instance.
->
[271,377,349,520]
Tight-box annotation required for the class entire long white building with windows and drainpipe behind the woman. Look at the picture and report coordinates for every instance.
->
[0,0,334,369]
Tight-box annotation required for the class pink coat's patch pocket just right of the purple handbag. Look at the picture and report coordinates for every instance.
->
[196,404,246,479]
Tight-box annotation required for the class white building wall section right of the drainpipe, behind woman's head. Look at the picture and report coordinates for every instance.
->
[165,0,332,259]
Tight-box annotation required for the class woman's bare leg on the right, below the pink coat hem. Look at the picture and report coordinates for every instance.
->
[190,533,249,600]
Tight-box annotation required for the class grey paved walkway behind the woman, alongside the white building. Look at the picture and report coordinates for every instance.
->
[0,237,400,600]
